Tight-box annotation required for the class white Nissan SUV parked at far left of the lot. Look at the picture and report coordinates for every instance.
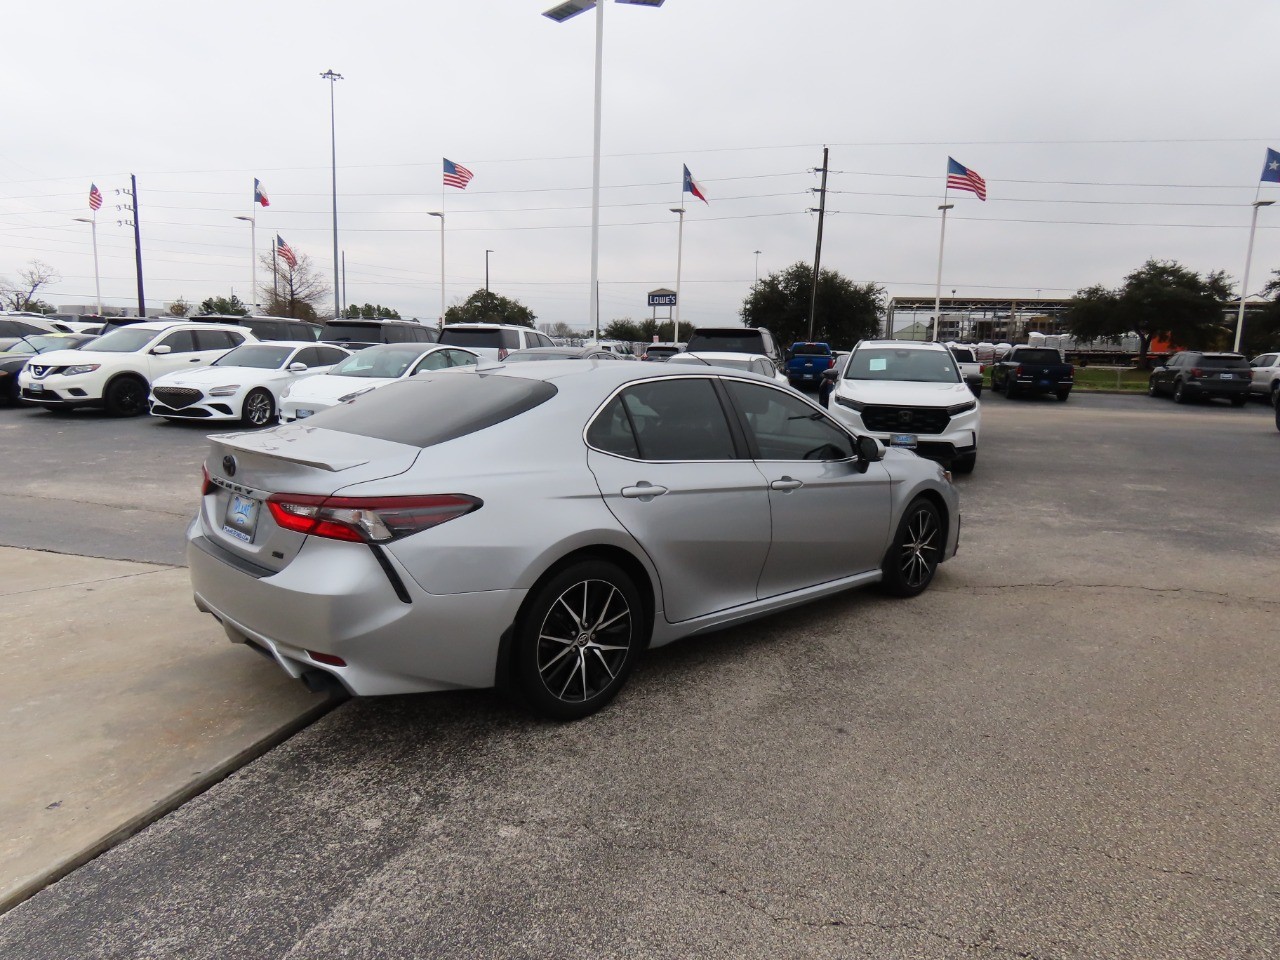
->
[18,320,255,416]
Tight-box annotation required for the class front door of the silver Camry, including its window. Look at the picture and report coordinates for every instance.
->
[724,379,891,599]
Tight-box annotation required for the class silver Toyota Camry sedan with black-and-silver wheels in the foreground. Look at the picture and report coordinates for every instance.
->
[187,361,960,719]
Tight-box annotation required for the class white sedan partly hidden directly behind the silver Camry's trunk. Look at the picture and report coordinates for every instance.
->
[280,343,480,424]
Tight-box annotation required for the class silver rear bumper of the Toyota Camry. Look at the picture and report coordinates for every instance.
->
[187,520,526,696]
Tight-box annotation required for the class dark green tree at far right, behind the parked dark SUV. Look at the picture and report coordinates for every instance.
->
[1065,260,1231,366]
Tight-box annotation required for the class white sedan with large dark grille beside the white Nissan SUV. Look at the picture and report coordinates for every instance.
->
[151,340,351,426]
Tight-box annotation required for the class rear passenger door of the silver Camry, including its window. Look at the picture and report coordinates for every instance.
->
[586,376,769,623]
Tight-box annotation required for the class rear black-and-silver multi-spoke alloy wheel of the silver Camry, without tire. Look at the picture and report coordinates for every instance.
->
[536,580,635,704]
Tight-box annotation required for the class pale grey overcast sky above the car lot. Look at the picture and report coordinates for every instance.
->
[0,0,1280,325]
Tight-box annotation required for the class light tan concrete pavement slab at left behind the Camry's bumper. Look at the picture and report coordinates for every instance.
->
[0,547,332,910]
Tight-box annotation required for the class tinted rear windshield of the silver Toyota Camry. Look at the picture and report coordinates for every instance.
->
[307,372,556,447]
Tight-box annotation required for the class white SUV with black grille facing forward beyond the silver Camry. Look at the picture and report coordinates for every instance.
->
[829,340,982,474]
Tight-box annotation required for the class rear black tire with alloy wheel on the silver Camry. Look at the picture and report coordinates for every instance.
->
[516,561,649,721]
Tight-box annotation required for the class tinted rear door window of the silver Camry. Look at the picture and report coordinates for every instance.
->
[620,378,735,461]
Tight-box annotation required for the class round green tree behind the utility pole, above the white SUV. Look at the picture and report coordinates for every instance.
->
[741,261,884,348]
